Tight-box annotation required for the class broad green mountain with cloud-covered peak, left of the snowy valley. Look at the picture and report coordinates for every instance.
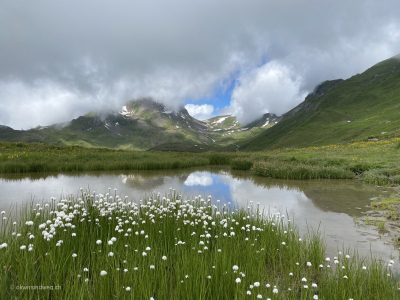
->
[0,100,211,150]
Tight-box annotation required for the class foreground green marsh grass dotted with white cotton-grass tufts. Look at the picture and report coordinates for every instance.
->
[0,189,399,300]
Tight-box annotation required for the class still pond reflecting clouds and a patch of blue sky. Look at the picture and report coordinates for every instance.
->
[0,167,398,259]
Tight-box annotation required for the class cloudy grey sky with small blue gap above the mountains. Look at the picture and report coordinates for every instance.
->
[0,0,400,129]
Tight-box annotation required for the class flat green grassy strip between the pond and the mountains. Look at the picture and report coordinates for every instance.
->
[0,138,400,185]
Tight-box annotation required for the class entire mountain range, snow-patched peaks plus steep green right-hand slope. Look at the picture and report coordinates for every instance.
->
[0,55,400,152]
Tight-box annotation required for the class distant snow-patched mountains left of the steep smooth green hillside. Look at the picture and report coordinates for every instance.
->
[0,99,279,152]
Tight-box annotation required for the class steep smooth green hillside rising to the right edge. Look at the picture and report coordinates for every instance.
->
[240,55,400,151]
